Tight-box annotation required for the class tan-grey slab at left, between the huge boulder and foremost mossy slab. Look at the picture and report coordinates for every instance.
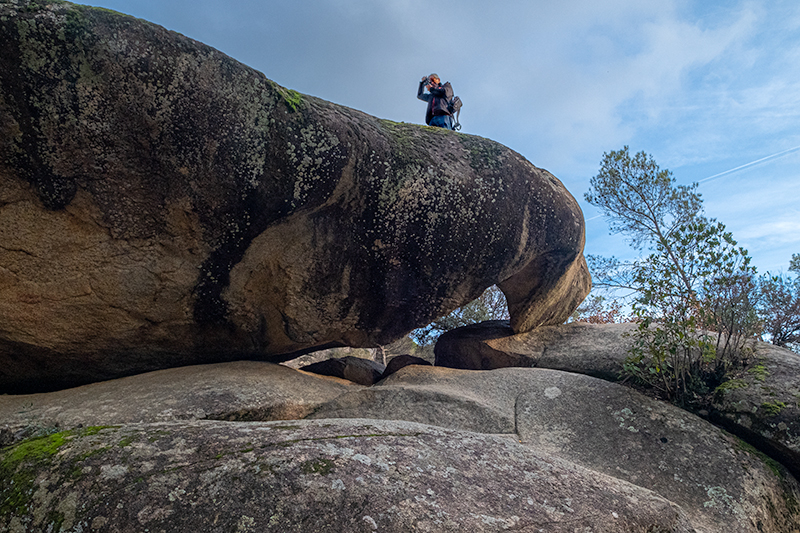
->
[0,361,360,446]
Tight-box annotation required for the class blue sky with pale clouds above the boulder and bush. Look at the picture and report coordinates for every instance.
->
[91,0,800,272]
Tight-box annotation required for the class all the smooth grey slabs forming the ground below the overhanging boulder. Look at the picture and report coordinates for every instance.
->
[0,362,800,533]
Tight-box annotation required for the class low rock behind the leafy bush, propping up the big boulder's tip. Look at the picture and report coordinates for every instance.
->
[436,321,800,477]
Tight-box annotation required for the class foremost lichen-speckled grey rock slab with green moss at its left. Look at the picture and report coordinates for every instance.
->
[0,420,694,533]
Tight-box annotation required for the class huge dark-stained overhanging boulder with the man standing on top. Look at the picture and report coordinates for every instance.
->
[0,0,590,392]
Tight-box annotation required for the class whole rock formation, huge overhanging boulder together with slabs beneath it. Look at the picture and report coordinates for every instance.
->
[0,0,800,533]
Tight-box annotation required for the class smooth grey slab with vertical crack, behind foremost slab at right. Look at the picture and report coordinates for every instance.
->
[311,367,800,533]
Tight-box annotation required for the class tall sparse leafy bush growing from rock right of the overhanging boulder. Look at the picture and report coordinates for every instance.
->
[586,146,758,404]
